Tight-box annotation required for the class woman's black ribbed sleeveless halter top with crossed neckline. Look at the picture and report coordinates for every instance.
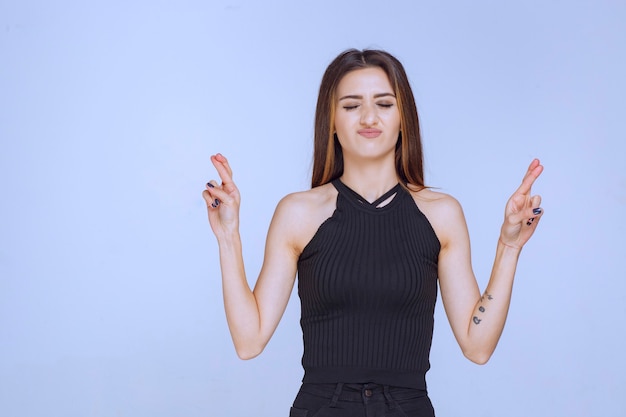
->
[298,179,440,389]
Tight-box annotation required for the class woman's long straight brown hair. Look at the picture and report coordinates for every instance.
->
[311,49,424,189]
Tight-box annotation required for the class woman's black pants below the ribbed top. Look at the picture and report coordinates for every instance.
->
[289,383,435,417]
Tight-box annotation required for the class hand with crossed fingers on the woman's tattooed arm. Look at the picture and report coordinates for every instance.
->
[500,159,543,249]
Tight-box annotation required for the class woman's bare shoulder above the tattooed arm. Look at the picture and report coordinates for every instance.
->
[411,188,467,246]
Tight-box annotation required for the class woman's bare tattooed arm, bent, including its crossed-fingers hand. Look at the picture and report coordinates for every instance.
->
[439,159,543,364]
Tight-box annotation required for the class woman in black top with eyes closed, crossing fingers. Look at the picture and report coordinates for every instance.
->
[203,50,543,417]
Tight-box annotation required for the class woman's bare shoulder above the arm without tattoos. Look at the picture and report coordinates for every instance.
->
[272,184,337,254]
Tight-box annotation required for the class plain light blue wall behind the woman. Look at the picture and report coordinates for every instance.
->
[0,0,626,417]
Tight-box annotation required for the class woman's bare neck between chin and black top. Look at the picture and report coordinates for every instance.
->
[340,156,398,202]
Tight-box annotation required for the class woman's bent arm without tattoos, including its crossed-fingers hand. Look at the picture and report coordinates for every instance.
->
[202,154,299,359]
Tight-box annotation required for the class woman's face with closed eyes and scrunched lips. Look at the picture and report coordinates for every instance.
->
[335,67,400,162]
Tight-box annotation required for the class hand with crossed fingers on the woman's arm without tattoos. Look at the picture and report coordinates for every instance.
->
[202,153,241,239]
